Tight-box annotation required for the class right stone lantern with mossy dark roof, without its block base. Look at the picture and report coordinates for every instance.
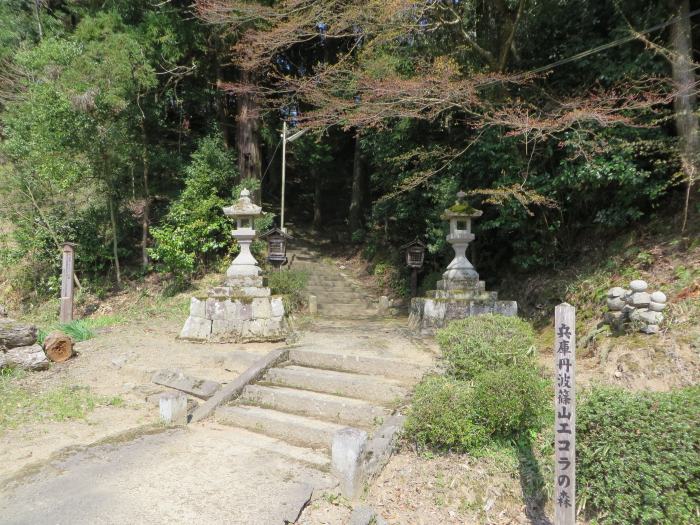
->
[442,191,483,282]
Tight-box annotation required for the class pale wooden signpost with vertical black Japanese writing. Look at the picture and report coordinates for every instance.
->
[554,303,576,525]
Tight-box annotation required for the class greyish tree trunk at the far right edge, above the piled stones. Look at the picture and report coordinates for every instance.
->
[670,0,700,231]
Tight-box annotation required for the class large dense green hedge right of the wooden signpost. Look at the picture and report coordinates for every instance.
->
[577,386,700,525]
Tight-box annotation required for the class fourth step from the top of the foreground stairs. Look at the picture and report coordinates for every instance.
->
[216,405,345,450]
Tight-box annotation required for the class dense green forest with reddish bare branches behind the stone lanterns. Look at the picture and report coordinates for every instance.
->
[0,0,700,305]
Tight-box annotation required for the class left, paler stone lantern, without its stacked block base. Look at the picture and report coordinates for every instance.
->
[223,189,262,280]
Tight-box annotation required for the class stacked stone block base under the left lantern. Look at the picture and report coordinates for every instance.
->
[180,277,287,343]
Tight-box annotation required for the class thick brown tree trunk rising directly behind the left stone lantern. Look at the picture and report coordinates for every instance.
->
[236,70,262,193]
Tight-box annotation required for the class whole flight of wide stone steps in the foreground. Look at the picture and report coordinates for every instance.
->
[215,347,428,482]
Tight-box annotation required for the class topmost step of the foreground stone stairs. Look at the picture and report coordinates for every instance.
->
[289,348,429,384]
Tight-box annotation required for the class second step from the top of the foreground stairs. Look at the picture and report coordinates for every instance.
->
[263,365,408,407]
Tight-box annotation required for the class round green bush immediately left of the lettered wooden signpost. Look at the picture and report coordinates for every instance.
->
[473,366,552,438]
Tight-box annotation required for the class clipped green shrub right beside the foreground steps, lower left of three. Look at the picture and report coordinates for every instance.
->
[406,376,488,452]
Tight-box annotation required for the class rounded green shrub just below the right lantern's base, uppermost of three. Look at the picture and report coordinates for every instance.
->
[436,314,535,379]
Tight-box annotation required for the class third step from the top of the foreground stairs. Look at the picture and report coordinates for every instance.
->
[239,385,390,428]
